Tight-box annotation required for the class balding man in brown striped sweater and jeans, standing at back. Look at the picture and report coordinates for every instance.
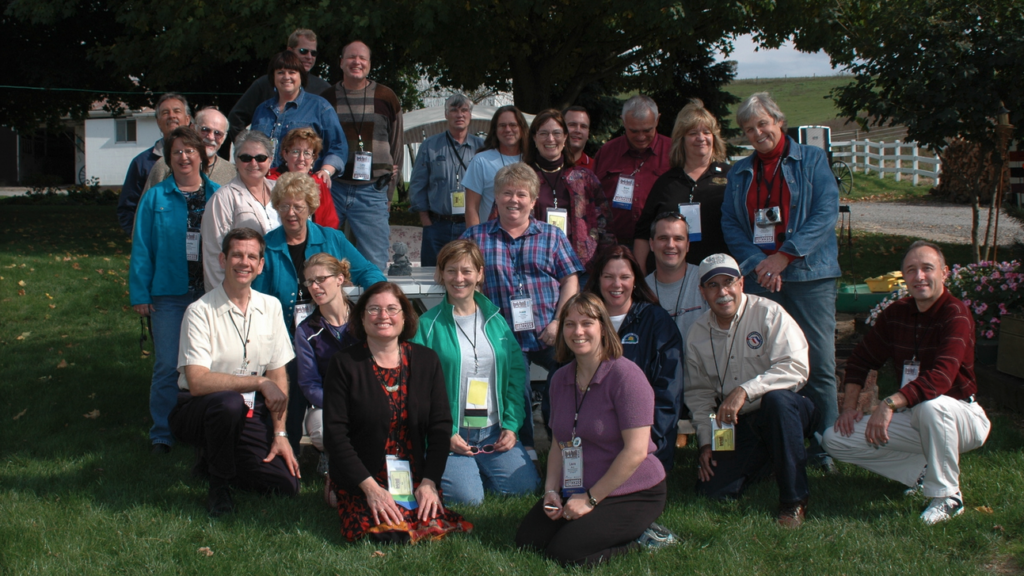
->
[321,40,403,272]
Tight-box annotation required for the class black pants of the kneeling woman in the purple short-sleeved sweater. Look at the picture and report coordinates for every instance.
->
[515,480,668,566]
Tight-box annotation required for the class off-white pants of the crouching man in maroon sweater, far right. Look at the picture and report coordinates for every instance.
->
[822,396,991,498]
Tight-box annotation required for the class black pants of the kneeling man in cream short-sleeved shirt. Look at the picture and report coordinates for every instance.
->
[169,392,299,496]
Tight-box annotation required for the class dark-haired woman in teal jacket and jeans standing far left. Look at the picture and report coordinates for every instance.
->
[128,128,219,454]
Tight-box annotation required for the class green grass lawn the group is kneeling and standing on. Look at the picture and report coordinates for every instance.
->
[0,204,1024,576]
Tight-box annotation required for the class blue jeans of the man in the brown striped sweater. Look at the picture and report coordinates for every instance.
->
[331,180,391,272]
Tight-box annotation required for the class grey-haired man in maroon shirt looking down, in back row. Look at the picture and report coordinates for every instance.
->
[593,94,672,247]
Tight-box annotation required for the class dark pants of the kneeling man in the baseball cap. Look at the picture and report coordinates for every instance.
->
[697,390,818,504]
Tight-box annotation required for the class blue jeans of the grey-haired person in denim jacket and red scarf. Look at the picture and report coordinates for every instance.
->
[758,278,839,462]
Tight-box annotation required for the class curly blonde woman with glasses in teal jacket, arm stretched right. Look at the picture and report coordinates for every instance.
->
[253,172,384,454]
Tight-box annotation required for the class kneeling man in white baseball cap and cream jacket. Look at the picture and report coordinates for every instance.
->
[684,254,818,528]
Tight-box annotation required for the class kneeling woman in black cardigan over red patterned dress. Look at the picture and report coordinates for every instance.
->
[324,282,473,542]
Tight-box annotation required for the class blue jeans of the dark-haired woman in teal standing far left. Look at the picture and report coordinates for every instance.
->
[150,290,203,446]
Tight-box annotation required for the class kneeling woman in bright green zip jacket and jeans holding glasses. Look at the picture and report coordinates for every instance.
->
[413,240,541,504]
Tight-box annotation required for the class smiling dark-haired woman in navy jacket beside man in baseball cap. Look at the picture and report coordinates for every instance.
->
[585,246,688,472]
